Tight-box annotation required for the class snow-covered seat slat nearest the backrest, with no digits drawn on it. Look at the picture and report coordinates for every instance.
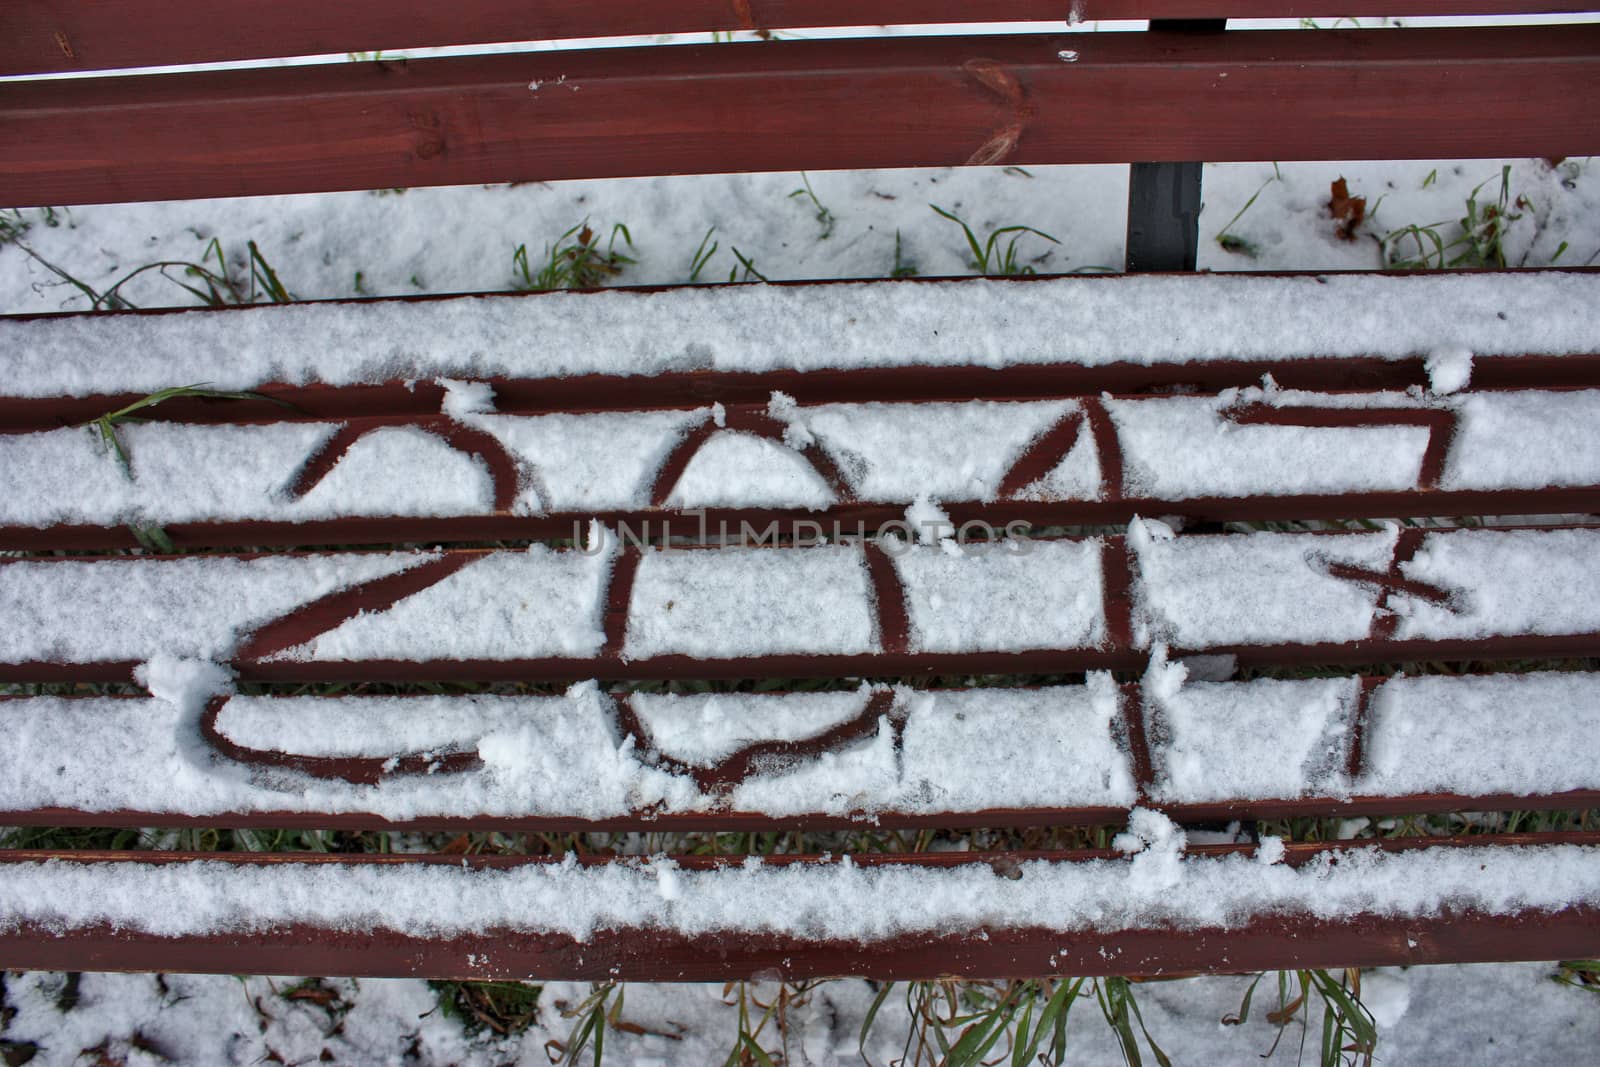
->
[0,267,1600,403]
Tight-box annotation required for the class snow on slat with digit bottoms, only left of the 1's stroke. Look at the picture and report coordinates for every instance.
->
[0,683,1134,821]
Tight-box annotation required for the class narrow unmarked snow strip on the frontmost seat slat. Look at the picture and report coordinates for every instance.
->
[0,838,1600,942]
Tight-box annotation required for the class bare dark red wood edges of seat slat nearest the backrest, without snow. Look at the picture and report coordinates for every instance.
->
[0,267,1600,434]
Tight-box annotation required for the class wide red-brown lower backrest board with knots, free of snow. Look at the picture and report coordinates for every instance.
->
[0,26,1600,206]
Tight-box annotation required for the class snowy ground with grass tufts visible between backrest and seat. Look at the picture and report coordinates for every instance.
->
[0,158,1600,314]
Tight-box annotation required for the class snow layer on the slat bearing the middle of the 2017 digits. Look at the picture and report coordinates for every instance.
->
[0,522,1600,664]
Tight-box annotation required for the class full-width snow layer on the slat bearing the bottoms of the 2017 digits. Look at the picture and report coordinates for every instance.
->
[0,667,1600,821]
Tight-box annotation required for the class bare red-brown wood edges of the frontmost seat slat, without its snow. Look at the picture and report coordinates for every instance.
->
[0,833,1600,981]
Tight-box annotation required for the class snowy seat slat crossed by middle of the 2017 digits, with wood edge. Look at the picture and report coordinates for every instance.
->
[0,523,1600,681]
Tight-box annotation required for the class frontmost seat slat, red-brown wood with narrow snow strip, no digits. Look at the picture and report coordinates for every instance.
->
[0,824,1600,981]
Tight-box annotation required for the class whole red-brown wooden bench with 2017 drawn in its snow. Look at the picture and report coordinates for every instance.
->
[0,0,1600,979]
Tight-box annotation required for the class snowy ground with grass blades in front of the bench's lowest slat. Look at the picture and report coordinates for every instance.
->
[0,963,1600,1067]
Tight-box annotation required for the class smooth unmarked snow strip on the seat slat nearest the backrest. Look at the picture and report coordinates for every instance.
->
[0,274,1600,397]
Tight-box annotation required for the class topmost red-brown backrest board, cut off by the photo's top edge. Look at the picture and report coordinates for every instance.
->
[0,0,1594,75]
